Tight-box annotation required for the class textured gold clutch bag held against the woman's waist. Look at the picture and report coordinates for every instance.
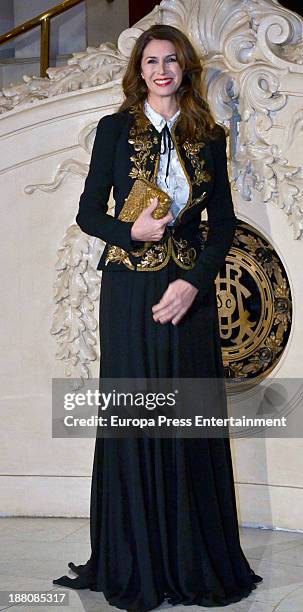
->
[118,178,172,221]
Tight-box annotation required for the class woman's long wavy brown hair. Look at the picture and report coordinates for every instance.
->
[118,24,220,143]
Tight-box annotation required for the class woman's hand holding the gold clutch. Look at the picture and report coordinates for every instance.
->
[131,198,174,242]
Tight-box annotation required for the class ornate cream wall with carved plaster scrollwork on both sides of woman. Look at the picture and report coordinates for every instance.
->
[0,0,303,529]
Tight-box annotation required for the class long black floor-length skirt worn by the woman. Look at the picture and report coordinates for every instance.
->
[55,261,262,610]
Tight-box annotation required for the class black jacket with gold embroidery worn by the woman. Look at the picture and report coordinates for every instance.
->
[76,110,237,296]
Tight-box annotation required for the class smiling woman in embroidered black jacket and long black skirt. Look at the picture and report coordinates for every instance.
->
[53,25,262,611]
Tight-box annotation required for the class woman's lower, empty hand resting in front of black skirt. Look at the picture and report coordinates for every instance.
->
[152,278,198,325]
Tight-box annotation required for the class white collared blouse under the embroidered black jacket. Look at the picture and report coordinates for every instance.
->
[144,100,189,225]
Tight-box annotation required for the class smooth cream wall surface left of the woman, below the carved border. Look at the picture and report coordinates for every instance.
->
[0,88,123,516]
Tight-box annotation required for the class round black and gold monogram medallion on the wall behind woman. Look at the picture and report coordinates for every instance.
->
[203,220,292,383]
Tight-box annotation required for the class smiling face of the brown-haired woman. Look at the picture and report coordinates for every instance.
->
[141,39,182,97]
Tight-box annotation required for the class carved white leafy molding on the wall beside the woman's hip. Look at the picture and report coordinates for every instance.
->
[51,224,104,380]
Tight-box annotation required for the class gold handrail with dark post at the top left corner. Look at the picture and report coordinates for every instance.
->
[0,0,113,77]
